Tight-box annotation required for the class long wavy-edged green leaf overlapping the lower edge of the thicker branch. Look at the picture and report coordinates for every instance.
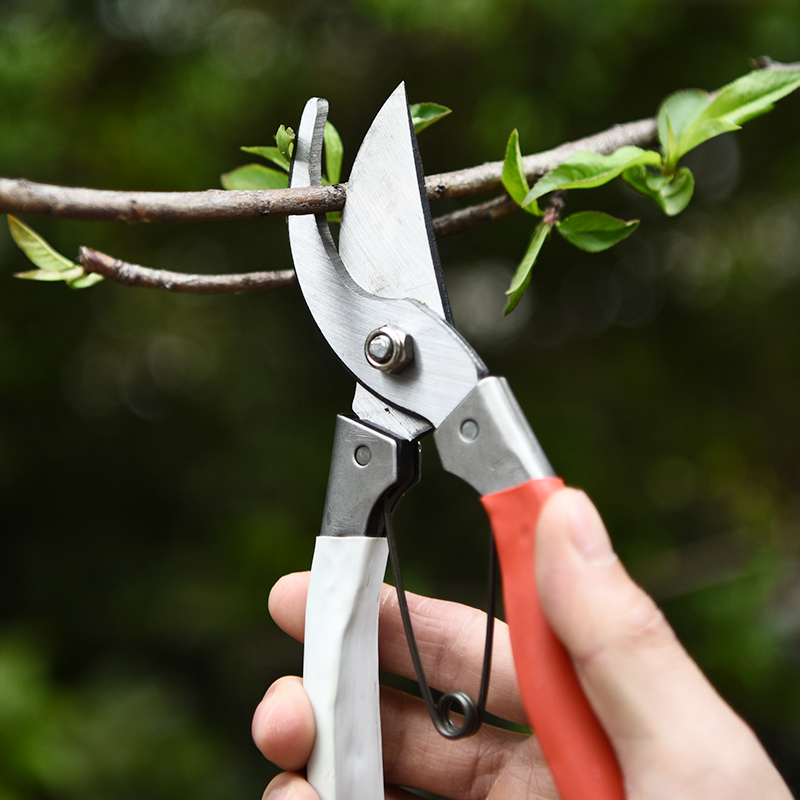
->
[523,145,661,206]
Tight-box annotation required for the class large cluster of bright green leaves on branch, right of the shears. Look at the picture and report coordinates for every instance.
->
[503,65,800,314]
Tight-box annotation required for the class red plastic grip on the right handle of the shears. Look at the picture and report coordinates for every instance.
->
[482,478,625,800]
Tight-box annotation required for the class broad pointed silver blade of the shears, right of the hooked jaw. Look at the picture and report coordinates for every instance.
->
[339,83,452,322]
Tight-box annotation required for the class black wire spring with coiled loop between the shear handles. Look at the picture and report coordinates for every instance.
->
[383,499,497,739]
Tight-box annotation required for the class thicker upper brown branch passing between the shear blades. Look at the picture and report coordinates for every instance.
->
[0,119,656,222]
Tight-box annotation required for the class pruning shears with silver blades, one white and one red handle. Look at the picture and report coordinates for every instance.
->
[289,84,624,800]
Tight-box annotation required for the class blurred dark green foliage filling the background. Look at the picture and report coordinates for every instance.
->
[0,0,800,800]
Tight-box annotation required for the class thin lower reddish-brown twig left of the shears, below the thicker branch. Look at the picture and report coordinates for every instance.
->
[78,247,295,294]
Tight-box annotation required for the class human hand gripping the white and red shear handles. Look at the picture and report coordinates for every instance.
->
[253,489,791,800]
